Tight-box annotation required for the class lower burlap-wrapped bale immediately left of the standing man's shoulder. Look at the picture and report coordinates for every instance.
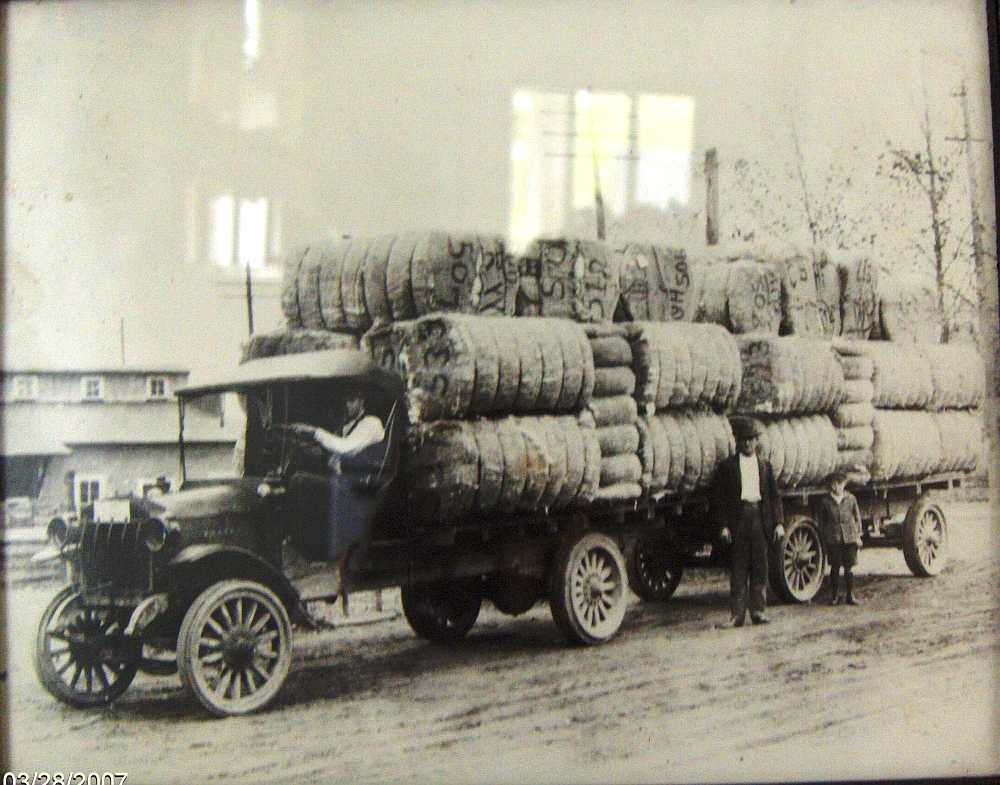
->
[639,411,736,494]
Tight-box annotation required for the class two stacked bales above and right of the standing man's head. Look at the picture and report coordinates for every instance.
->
[734,335,846,488]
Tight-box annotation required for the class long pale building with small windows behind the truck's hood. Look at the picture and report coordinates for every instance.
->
[0,368,239,519]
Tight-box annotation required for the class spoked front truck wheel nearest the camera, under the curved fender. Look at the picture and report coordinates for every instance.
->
[177,581,292,716]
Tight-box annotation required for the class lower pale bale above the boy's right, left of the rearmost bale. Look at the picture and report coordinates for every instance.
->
[872,409,942,480]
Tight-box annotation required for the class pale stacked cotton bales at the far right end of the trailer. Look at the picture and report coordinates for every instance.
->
[838,341,983,481]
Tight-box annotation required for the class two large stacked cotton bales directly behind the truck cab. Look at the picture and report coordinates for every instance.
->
[362,314,602,521]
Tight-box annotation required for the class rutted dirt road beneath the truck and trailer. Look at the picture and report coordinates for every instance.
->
[5,503,1000,783]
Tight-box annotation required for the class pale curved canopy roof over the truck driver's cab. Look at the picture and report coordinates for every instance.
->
[177,349,402,398]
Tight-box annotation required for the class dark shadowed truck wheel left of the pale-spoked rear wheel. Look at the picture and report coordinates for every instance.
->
[400,580,483,643]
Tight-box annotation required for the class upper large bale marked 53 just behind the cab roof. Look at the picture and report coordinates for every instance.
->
[364,314,593,422]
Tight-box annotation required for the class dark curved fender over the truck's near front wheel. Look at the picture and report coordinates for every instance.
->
[170,544,309,623]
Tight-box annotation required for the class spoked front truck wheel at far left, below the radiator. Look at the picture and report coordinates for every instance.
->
[35,586,142,709]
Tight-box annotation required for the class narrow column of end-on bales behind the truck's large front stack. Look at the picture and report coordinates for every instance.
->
[586,323,642,501]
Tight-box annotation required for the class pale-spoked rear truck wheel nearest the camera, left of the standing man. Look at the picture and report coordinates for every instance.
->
[549,532,628,645]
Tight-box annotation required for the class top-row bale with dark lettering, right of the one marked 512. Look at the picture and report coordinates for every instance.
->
[614,243,701,322]
